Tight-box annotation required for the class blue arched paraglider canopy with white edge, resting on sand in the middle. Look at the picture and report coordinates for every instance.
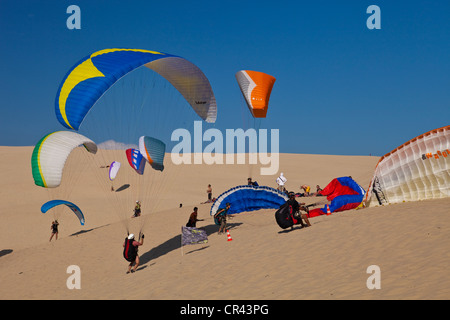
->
[210,185,289,215]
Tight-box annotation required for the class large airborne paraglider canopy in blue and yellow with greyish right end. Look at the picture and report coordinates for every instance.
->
[55,49,217,130]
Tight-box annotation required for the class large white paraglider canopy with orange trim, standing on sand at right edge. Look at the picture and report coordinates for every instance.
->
[364,126,450,206]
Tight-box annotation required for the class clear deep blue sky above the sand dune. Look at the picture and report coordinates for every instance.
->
[0,0,450,156]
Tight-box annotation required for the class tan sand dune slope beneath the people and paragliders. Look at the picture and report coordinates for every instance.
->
[0,147,450,300]
